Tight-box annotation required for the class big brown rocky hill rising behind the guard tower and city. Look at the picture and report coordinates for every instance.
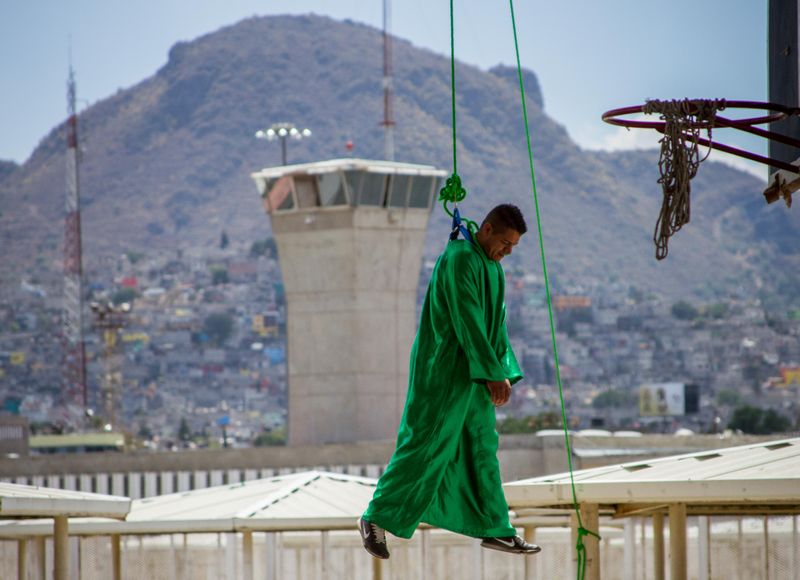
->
[0,16,800,304]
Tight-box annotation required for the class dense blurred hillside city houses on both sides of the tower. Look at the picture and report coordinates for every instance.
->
[0,232,800,449]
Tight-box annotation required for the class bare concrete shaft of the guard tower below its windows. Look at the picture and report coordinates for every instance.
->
[271,206,429,447]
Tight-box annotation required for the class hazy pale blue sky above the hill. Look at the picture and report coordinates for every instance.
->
[0,0,767,176]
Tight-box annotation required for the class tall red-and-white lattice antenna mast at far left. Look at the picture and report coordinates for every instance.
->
[62,62,87,410]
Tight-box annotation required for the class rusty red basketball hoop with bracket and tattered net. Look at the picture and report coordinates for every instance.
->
[602,99,800,260]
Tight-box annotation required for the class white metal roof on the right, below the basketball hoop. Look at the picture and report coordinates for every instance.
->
[503,438,800,513]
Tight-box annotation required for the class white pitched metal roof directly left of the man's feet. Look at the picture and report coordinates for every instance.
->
[0,471,377,537]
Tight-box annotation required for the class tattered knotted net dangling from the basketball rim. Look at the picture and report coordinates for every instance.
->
[642,99,725,260]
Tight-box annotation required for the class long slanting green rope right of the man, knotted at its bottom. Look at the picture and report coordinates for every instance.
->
[508,0,600,580]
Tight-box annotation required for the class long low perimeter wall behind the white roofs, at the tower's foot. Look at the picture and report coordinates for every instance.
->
[0,435,777,498]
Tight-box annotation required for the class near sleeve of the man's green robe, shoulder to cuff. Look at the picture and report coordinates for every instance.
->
[444,247,506,383]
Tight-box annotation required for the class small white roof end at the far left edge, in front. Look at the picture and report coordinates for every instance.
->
[0,482,131,518]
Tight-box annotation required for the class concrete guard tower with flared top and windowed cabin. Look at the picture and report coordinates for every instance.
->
[252,159,445,446]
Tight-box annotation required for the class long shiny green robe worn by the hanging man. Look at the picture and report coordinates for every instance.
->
[363,240,522,538]
